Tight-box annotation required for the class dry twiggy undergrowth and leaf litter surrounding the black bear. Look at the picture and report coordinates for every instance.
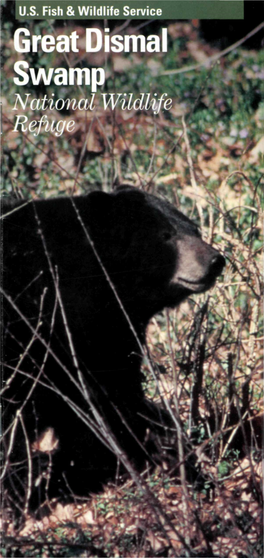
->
[2,13,264,558]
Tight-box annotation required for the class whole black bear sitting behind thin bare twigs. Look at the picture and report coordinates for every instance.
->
[2,186,224,511]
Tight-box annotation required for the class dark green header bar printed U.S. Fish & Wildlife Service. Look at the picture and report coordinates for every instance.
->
[16,0,244,21]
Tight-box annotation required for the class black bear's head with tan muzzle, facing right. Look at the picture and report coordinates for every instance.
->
[85,186,225,314]
